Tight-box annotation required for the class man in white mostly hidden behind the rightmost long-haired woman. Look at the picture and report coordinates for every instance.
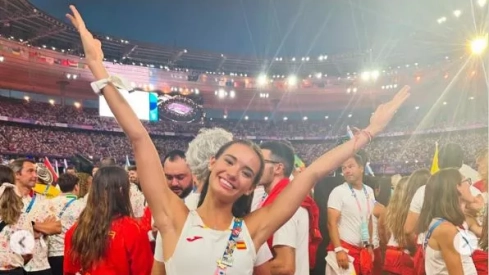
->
[404,143,484,245]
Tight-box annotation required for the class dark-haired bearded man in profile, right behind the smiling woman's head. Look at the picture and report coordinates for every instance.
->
[260,141,306,275]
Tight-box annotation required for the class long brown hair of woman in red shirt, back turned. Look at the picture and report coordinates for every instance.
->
[71,166,133,270]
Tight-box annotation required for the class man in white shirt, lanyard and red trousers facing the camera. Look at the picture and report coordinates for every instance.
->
[327,155,375,275]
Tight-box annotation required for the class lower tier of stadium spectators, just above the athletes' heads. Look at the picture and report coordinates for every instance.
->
[0,124,487,174]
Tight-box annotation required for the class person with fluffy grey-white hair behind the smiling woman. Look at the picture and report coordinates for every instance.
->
[152,128,273,275]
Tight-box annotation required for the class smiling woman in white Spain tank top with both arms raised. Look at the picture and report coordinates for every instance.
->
[67,6,409,275]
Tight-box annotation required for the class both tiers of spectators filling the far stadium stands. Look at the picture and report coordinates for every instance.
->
[0,99,487,174]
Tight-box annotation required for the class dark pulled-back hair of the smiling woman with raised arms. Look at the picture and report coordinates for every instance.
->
[197,140,265,218]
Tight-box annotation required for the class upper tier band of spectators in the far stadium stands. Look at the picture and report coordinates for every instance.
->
[0,98,487,136]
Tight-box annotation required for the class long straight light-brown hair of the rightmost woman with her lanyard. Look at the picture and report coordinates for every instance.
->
[417,168,465,234]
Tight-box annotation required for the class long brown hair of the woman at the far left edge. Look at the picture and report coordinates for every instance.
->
[0,165,24,224]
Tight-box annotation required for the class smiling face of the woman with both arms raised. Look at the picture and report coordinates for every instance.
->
[209,143,262,203]
